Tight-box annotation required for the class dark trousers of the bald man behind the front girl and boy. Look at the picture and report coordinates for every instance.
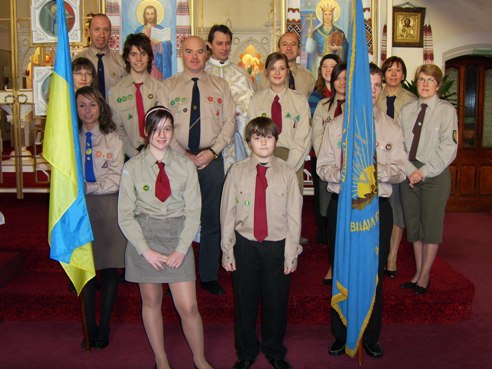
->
[198,155,224,282]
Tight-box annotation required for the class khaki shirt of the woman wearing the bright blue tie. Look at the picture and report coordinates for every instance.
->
[79,125,125,195]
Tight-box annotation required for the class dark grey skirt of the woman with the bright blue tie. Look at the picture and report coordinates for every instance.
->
[85,192,127,270]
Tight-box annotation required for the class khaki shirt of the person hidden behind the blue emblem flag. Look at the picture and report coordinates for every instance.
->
[316,107,408,197]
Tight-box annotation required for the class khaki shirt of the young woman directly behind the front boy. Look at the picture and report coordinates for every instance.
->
[248,88,311,171]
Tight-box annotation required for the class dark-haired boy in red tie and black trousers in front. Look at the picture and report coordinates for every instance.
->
[220,117,302,369]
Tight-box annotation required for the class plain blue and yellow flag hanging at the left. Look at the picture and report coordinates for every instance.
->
[43,0,95,294]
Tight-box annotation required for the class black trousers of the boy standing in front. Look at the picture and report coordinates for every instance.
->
[232,232,290,360]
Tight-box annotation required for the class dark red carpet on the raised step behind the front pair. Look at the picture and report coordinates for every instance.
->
[0,194,474,324]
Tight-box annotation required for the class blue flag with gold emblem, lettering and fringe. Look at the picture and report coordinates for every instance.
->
[331,0,379,357]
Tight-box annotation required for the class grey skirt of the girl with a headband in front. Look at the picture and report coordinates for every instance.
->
[125,214,195,283]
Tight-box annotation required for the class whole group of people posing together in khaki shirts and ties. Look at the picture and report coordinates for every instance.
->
[67,14,457,369]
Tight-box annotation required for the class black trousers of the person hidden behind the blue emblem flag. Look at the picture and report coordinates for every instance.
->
[328,194,393,343]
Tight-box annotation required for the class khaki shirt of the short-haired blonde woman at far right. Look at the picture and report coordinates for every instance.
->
[398,95,458,177]
